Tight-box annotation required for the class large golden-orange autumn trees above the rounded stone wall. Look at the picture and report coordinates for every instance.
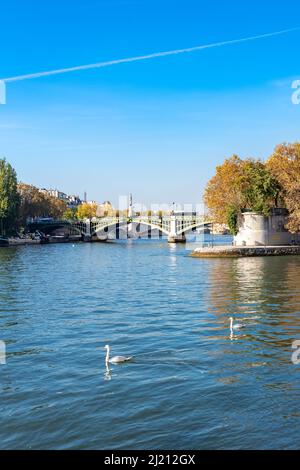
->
[204,142,300,235]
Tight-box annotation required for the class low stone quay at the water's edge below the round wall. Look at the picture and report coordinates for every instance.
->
[191,245,300,258]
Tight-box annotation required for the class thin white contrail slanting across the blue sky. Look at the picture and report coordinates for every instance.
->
[2,28,300,83]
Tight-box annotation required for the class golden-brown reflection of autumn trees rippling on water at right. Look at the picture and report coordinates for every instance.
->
[207,256,300,348]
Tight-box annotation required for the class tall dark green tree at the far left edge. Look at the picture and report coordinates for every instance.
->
[0,159,20,235]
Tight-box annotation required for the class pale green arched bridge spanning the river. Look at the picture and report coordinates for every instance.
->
[29,214,212,243]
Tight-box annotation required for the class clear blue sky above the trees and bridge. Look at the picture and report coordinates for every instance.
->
[0,0,300,204]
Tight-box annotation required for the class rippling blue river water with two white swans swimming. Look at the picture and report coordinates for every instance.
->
[0,240,300,450]
